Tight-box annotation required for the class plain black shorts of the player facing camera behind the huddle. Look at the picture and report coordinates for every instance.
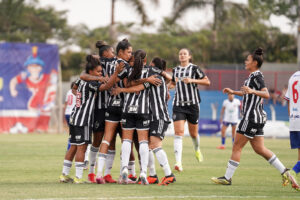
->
[173,104,199,124]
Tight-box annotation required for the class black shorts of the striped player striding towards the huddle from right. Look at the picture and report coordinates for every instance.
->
[236,119,265,139]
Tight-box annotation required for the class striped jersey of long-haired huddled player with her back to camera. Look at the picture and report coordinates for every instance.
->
[123,66,151,114]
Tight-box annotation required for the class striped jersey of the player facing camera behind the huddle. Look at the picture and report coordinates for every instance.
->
[172,63,205,106]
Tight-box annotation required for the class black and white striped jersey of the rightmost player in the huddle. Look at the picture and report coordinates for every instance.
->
[149,68,170,122]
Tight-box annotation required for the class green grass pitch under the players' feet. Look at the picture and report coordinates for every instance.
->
[0,134,300,200]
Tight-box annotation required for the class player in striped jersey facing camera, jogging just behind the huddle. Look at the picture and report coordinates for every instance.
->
[171,48,210,172]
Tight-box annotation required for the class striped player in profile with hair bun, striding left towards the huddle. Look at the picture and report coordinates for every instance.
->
[212,48,299,191]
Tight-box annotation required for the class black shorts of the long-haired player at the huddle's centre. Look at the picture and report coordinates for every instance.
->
[121,113,150,130]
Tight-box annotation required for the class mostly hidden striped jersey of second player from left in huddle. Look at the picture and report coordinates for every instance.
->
[95,58,116,109]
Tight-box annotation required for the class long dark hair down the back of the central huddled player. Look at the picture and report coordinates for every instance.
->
[128,49,147,83]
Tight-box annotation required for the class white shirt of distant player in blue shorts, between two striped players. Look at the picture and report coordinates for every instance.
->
[223,98,241,123]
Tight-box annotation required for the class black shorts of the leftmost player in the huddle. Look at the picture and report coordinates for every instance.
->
[70,125,92,145]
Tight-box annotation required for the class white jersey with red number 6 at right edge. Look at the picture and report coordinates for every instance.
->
[284,71,300,131]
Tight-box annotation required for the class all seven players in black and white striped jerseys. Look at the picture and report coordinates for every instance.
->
[60,39,300,190]
